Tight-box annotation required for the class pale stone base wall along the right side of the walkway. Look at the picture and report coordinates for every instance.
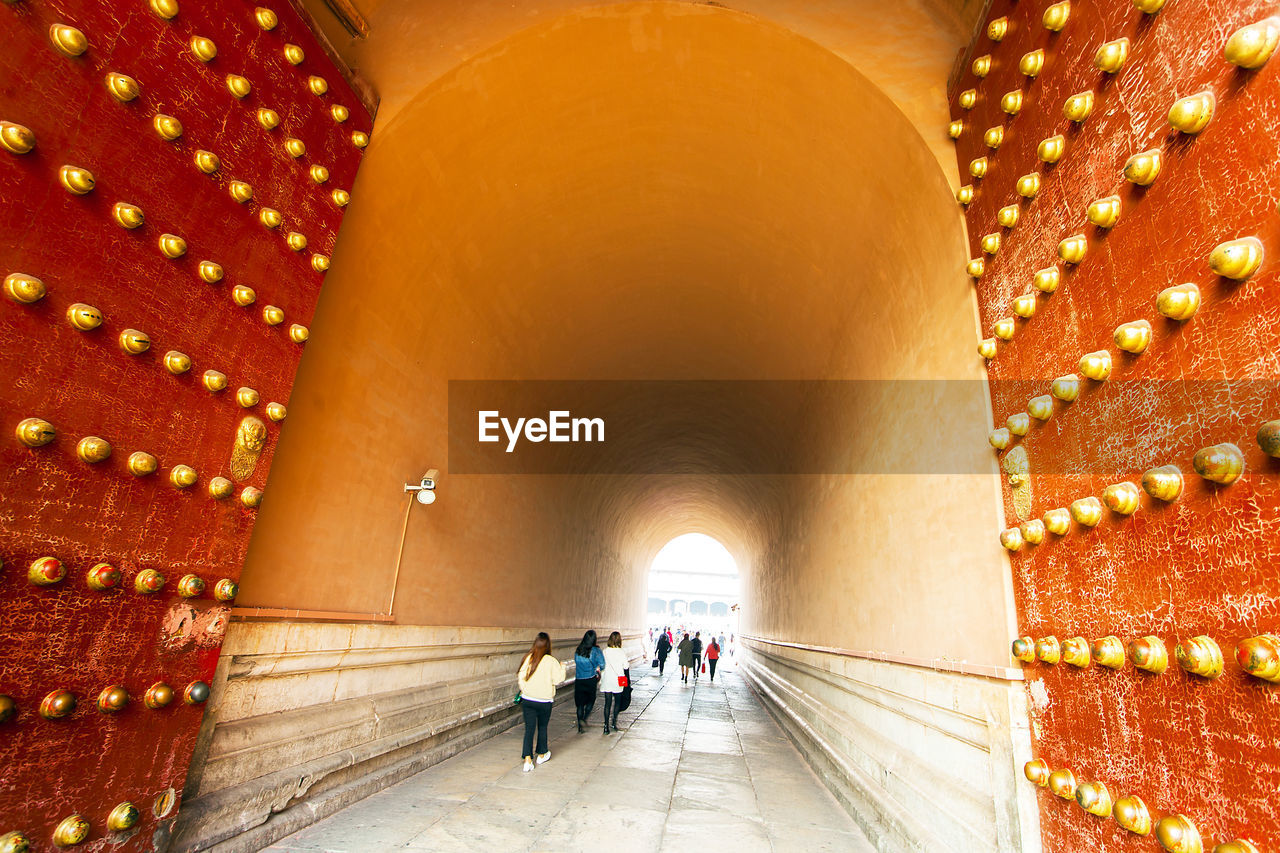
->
[741,638,1041,853]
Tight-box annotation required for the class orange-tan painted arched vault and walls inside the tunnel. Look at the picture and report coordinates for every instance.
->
[239,3,1009,665]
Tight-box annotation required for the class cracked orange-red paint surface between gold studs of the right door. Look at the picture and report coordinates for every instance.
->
[952,0,1280,853]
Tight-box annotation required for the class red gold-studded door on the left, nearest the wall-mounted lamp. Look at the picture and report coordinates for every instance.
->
[0,0,371,850]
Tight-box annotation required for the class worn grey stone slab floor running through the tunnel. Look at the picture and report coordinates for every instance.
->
[268,667,874,853]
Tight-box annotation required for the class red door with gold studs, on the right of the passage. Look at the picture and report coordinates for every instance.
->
[952,0,1280,853]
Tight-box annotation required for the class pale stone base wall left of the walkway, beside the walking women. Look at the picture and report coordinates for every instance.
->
[169,622,646,853]
